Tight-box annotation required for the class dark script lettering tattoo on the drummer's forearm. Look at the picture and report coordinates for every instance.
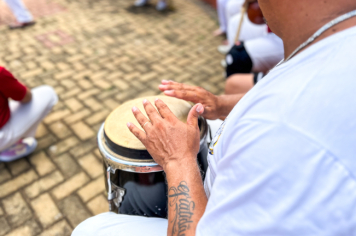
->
[168,181,195,236]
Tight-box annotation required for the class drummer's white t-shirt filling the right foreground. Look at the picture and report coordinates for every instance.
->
[197,27,356,236]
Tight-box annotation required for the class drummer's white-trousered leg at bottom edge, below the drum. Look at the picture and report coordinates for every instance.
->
[72,212,168,236]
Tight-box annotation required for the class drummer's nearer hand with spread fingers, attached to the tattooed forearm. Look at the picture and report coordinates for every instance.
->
[127,99,204,170]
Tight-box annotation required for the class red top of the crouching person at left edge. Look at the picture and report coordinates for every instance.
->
[0,67,27,129]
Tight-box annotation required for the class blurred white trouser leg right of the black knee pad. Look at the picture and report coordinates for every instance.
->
[245,33,284,72]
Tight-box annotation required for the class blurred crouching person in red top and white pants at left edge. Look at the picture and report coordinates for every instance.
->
[0,67,58,162]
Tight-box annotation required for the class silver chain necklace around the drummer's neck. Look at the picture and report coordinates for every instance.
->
[275,10,356,67]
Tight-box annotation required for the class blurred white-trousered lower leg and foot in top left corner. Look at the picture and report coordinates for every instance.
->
[4,0,36,29]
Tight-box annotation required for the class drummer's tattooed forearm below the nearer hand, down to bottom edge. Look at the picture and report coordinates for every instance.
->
[165,158,208,236]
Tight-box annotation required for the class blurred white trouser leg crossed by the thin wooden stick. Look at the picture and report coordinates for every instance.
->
[227,13,267,47]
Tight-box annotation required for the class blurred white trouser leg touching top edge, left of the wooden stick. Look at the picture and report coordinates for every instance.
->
[216,0,244,32]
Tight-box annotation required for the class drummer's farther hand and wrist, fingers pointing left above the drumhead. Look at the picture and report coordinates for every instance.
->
[158,80,221,120]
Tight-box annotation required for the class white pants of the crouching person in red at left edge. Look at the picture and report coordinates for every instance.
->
[0,85,58,152]
